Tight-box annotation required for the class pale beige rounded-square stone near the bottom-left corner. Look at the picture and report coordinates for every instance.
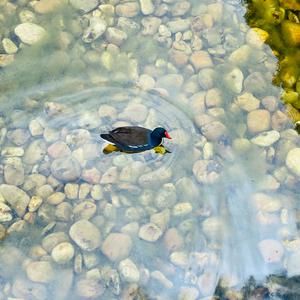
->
[26,261,54,283]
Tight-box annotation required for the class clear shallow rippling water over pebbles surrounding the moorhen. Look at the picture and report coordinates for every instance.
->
[0,0,300,299]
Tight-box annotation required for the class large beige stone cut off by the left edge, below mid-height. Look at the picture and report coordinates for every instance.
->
[0,184,30,217]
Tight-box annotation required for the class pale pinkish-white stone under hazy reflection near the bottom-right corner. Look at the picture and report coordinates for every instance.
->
[258,239,284,263]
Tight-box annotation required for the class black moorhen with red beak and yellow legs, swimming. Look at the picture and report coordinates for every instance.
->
[100,126,171,154]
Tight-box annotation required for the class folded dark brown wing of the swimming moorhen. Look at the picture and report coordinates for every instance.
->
[109,126,151,146]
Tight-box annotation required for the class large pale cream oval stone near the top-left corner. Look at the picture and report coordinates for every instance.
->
[15,23,46,45]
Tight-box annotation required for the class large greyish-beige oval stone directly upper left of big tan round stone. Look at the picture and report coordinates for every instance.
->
[69,220,101,251]
